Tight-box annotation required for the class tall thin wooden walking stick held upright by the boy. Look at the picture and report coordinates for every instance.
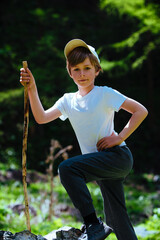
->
[22,61,31,232]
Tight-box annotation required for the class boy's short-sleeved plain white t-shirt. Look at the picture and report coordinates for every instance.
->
[54,86,126,154]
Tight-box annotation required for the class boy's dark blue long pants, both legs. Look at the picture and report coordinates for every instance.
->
[59,146,137,240]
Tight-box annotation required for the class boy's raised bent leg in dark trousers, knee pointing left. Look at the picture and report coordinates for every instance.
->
[59,146,133,217]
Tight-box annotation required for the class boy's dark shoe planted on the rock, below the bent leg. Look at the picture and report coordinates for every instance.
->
[78,218,113,240]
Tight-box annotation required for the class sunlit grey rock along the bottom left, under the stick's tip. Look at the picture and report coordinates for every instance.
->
[0,226,82,240]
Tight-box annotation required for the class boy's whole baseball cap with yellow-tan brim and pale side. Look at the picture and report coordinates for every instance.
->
[64,39,100,63]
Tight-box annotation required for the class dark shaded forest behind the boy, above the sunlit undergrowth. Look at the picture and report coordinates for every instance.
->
[0,0,160,173]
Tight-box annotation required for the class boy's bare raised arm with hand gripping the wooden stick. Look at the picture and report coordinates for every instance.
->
[20,68,61,124]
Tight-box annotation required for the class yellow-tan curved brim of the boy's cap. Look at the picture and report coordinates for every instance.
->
[64,39,90,58]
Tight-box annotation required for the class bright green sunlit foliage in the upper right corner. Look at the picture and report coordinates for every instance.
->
[100,0,160,75]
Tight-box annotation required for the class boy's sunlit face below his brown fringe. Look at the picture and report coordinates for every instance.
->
[70,58,99,93]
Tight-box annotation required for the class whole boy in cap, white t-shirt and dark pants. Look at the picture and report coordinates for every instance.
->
[20,39,148,240]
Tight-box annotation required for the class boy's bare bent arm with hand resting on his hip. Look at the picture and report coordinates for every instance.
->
[97,98,148,151]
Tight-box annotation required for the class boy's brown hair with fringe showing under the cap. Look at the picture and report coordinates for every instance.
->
[67,47,103,73]
